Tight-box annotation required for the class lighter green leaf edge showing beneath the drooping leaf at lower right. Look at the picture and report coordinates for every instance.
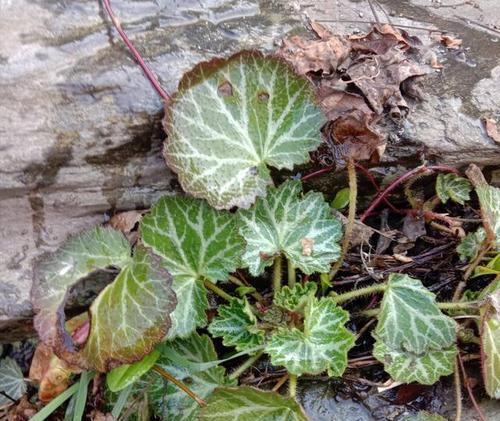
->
[373,340,457,385]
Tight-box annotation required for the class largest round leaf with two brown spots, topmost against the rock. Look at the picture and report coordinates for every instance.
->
[165,52,326,209]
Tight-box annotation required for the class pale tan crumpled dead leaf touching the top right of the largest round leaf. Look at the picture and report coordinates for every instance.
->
[276,32,350,75]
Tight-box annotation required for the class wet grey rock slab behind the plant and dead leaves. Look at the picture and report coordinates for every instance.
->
[0,0,500,341]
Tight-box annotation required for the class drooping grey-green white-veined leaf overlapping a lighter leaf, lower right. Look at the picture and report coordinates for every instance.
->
[375,274,456,354]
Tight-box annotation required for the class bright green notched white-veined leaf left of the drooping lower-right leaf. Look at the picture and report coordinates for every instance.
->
[266,296,355,376]
